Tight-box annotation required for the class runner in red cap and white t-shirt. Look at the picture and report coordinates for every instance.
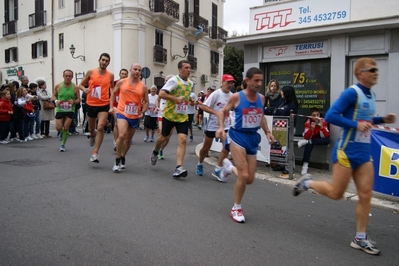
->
[195,74,236,182]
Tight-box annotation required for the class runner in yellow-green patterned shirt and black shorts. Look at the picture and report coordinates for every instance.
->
[151,60,193,178]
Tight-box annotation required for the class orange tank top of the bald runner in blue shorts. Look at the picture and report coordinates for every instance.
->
[117,78,144,119]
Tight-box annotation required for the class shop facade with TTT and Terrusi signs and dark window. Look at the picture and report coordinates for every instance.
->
[228,0,399,164]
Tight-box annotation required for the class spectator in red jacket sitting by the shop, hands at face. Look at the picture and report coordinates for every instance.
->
[298,108,330,175]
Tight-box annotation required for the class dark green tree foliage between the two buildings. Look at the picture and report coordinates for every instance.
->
[223,44,244,90]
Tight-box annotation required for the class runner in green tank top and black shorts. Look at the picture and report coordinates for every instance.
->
[53,69,80,152]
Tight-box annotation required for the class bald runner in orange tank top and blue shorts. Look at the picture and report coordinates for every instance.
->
[109,63,148,173]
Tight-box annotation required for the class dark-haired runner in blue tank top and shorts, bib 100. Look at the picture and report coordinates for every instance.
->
[216,67,274,223]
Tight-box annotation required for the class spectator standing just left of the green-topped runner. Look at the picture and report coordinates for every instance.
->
[37,80,54,138]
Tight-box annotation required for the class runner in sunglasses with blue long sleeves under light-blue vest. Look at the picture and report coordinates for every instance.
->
[293,58,396,255]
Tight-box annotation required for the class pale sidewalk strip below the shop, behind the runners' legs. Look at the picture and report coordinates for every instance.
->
[195,143,399,213]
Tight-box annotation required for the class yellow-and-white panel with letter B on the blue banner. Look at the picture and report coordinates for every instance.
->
[379,146,399,180]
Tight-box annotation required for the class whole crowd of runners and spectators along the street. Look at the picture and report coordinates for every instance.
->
[0,56,396,254]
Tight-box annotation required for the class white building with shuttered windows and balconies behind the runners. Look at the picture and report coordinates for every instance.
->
[0,0,227,92]
